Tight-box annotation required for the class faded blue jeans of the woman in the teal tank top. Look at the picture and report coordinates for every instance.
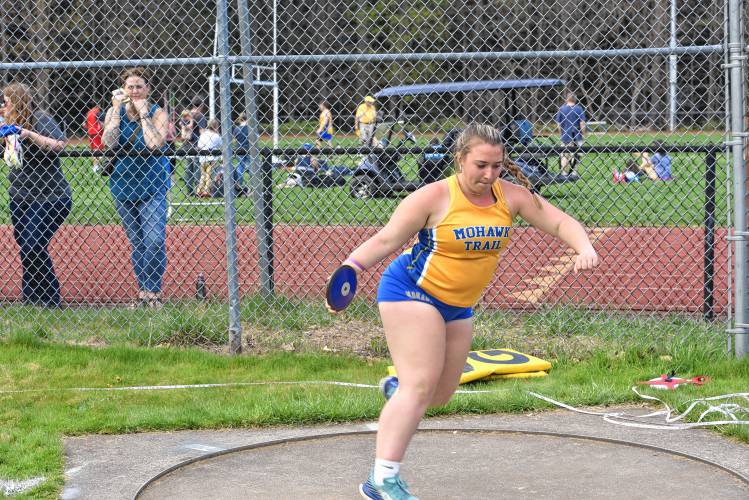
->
[114,193,166,293]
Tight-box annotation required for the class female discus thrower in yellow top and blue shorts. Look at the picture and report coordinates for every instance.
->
[328,124,598,500]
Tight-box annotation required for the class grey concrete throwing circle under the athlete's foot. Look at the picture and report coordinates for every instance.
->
[135,429,749,500]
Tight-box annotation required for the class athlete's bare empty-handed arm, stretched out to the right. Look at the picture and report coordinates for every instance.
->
[502,183,598,272]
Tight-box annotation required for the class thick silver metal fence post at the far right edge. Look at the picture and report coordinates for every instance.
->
[727,0,749,358]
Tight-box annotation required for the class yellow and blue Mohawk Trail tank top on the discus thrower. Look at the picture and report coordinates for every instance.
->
[406,175,512,307]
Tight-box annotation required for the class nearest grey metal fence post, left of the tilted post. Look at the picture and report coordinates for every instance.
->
[216,0,242,354]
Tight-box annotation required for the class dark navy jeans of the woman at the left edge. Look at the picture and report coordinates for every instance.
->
[10,197,72,307]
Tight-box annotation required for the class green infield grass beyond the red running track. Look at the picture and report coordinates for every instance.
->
[0,133,727,227]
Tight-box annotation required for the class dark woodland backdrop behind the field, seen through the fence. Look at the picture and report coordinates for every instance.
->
[0,0,723,131]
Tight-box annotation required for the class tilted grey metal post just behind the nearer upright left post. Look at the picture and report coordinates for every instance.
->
[237,0,273,297]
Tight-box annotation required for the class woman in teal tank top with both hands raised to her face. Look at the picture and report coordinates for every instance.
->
[103,68,169,307]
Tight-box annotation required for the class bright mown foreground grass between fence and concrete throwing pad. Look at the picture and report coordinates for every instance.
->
[0,319,749,499]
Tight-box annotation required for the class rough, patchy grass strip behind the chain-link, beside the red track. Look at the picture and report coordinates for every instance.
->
[0,295,725,356]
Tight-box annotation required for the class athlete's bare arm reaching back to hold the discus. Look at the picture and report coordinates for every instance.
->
[349,185,439,269]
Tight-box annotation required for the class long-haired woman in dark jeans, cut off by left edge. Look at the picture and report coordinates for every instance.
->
[2,83,71,307]
